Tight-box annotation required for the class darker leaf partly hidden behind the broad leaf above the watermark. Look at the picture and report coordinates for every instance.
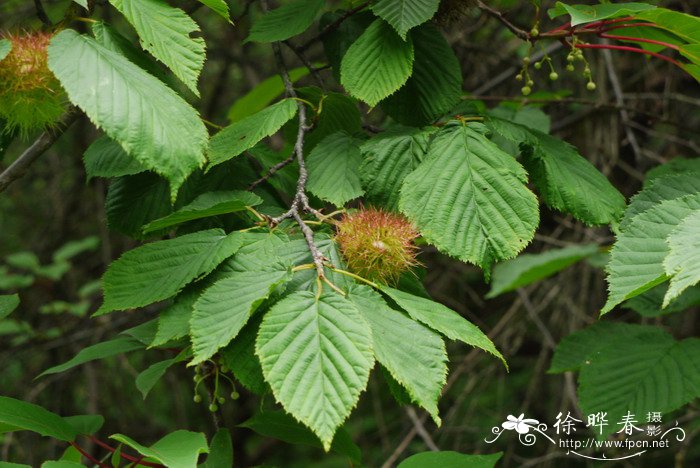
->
[547,321,666,374]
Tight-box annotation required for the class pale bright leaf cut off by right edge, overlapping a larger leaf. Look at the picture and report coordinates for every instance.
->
[663,210,700,307]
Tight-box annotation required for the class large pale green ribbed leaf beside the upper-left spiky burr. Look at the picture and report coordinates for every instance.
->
[49,29,207,199]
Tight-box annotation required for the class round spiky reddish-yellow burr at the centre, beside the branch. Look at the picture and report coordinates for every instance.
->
[336,208,418,284]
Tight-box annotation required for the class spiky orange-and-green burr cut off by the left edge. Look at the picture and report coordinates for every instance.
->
[0,32,67,136]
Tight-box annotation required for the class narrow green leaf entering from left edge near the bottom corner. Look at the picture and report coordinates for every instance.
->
[0,396,78,442]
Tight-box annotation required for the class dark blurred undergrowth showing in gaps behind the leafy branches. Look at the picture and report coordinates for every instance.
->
[0,0,700,467]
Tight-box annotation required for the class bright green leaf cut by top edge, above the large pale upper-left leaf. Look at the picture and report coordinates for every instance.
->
[109,0,206,96]
